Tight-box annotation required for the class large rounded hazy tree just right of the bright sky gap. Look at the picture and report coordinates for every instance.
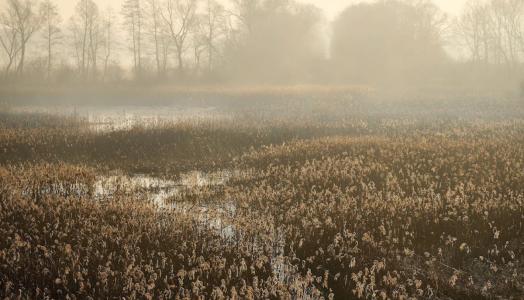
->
[331,0,447,83]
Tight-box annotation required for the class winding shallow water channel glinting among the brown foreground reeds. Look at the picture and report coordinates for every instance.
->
[13,170,301,283]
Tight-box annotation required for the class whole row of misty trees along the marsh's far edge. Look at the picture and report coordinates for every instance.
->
[0,0,524,83]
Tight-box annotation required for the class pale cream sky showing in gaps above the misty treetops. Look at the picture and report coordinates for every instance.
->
[55,0,466,19]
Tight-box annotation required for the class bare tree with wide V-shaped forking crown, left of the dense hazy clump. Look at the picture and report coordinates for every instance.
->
[160,0,197,73]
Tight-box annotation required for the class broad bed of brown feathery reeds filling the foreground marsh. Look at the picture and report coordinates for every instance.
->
[0,95,524,299]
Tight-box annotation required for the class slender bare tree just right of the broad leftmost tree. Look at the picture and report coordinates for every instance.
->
[41,0,61,78]
